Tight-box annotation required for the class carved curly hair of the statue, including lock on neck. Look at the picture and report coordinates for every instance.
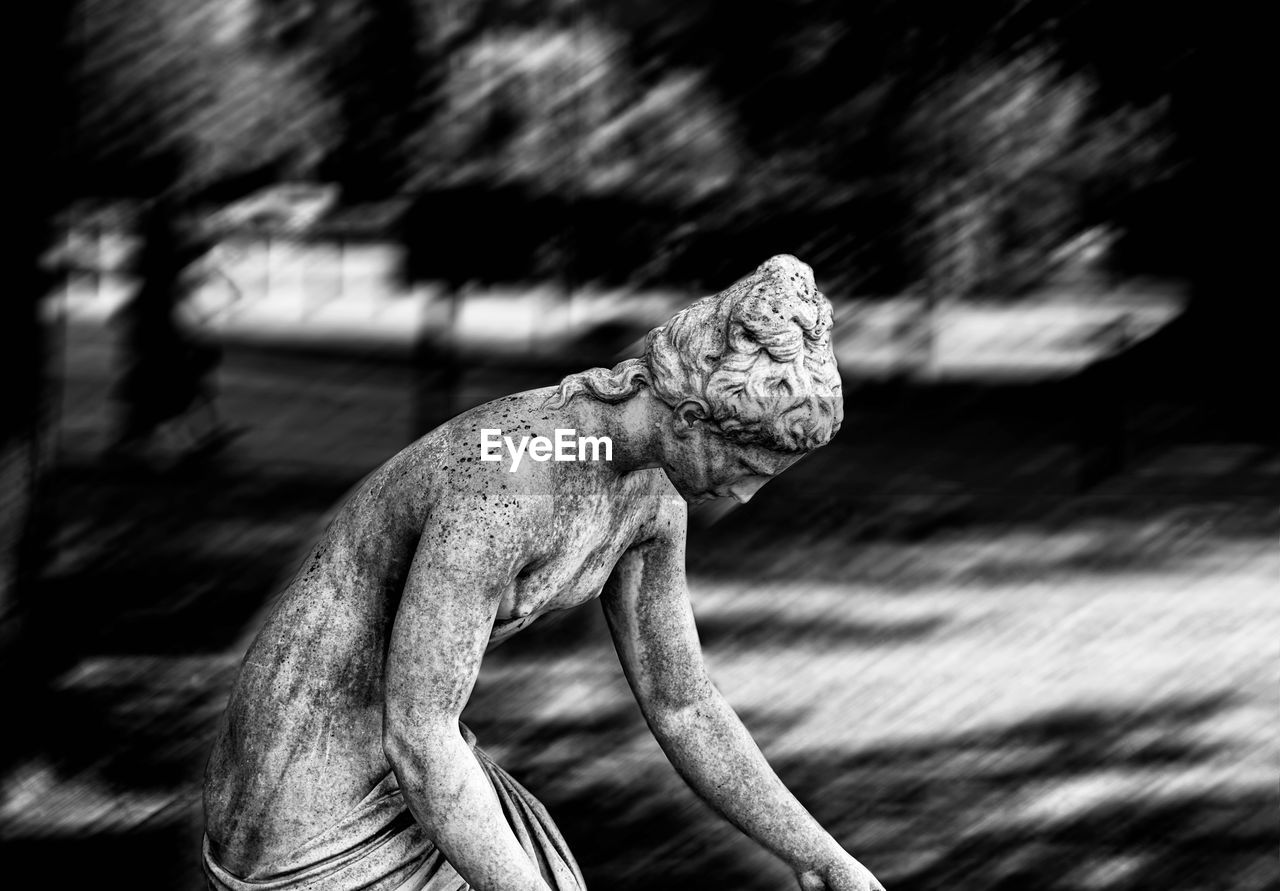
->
[552,255,844,452]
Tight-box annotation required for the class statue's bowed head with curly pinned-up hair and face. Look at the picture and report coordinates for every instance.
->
[547,255,844,502]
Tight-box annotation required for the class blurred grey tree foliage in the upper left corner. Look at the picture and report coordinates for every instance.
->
[69,0,337,196]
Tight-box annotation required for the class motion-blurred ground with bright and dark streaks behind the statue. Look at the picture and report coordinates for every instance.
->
[0,318,1280,891]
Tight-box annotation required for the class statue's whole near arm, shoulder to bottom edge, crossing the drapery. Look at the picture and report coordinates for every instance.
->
[383,506,549,891]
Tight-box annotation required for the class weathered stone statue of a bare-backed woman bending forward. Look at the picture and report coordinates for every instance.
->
[205,256,881,891]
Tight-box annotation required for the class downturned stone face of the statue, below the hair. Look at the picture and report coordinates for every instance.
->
[663,410,801,504]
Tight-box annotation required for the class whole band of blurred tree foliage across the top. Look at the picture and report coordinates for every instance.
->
[60,0,1193,296]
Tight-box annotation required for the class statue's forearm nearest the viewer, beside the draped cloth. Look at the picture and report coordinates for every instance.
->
[388,732,549,891]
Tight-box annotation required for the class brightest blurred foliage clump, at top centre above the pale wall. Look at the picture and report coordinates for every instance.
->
[422,24,741,204]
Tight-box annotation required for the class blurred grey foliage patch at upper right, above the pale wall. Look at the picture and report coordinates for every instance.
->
[899,50,1171,296]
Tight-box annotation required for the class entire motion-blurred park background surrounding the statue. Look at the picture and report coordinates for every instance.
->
[0,0,1280,891]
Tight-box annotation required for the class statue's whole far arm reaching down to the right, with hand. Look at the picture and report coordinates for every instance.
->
[602,502,881,891]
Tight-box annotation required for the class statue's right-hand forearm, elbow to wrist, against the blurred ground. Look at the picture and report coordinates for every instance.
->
[649,690,844,872]
